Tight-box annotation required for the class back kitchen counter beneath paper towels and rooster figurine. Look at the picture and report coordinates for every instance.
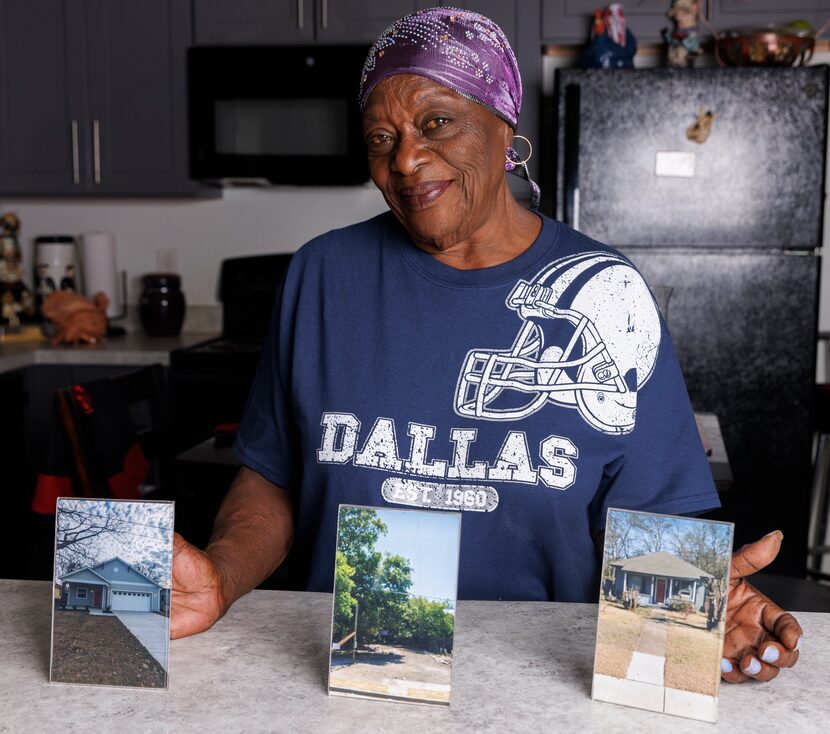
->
[0,332,217,374]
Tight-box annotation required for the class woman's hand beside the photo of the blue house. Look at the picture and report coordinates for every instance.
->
[170,533,229,639]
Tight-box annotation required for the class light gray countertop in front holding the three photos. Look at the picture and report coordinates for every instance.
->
[0,581,830,734]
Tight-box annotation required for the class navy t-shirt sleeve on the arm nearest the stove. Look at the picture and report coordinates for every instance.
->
[234,266,301,491]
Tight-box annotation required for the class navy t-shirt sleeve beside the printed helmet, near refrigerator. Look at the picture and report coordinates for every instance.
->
[590,325,720,534]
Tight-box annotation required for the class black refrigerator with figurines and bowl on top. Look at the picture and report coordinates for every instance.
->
[548,66,828,576]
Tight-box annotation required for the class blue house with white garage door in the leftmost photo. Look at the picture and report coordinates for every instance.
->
[61,556,169,615]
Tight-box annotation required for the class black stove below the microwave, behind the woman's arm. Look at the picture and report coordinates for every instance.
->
[170,254,291,448]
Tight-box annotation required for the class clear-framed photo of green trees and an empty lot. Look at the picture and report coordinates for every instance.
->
[329,505,461,705]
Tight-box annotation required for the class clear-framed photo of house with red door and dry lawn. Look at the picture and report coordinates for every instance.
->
[592,509,733,721]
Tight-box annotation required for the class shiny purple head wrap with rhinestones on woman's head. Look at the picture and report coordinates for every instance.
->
[359,8,522,129]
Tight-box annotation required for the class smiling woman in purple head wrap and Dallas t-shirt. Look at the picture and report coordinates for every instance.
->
[172,8,800,680]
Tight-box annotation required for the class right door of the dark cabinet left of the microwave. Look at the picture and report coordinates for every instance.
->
[86,0,198,195]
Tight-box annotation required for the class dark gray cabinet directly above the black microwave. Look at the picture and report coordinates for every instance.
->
[193,0,437,45]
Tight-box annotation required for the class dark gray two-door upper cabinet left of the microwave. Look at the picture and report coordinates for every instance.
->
[0,0,199,196]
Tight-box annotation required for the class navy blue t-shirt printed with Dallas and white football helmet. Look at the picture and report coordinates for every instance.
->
[236,213,718,601]
